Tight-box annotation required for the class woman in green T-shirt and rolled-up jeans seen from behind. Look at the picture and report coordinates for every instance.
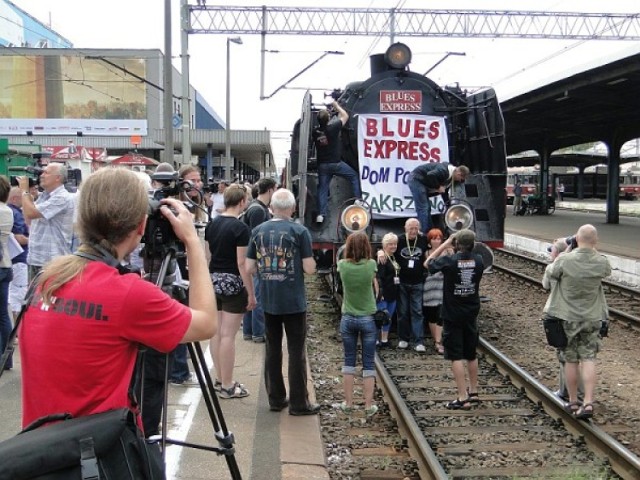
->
[338,232,378,416]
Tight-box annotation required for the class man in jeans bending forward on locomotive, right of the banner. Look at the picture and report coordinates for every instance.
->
[408,162,471,233]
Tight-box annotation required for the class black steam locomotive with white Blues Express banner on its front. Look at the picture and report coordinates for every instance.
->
[283,43,507,268]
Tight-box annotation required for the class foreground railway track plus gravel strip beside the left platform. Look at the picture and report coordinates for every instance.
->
[310,272,640,479]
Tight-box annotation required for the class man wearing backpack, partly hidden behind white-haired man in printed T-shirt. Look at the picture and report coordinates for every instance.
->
[241,178,277,343]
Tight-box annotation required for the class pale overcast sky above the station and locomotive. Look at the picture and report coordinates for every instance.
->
[12,0,640,166]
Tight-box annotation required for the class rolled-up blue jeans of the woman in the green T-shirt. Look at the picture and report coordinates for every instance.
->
[340,314,378,377]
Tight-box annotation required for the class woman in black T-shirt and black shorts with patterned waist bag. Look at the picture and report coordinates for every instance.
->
[205,184,256,398]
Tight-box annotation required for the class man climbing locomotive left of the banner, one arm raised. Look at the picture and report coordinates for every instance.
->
[313,100,362,223]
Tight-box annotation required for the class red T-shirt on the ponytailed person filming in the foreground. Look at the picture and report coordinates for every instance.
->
[19,262,191,426]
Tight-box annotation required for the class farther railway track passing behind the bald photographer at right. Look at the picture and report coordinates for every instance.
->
[493,249,640,329]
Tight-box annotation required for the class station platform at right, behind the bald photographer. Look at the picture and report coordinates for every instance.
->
[505,200,640,287]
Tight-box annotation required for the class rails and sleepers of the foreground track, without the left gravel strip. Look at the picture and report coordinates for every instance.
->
[377,340,640,479]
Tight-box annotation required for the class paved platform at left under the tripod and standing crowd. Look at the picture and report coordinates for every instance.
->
[0,332,329,480]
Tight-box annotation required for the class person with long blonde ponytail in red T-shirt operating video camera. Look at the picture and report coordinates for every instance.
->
[19,168,218,426]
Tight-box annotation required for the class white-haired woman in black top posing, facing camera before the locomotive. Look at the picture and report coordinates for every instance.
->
[377,233,400,348]
